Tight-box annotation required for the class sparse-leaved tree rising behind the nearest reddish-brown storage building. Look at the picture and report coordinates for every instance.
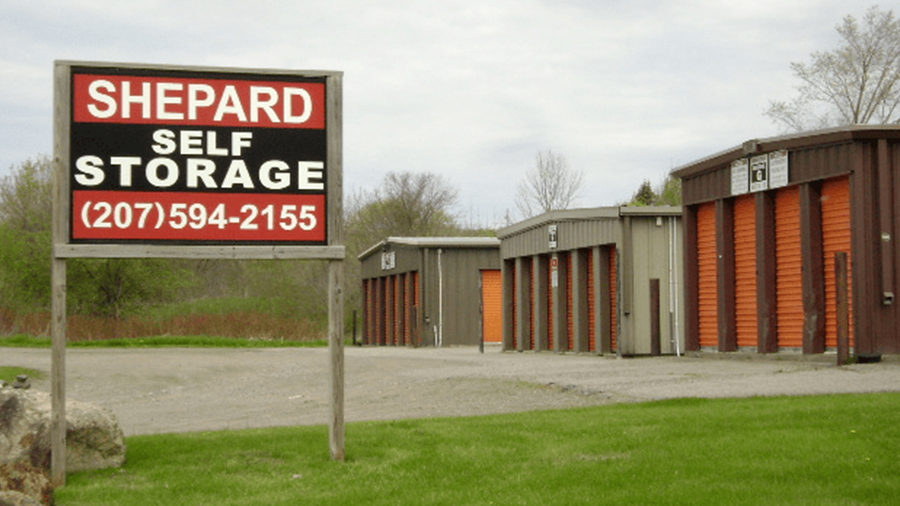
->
[765,6,900,132]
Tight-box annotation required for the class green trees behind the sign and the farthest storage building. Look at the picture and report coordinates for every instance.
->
[0,157,491,325]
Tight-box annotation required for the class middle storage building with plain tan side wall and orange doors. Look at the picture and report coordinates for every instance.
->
[497,207,684,355]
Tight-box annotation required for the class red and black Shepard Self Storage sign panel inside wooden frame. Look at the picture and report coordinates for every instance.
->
[70,67,327,245]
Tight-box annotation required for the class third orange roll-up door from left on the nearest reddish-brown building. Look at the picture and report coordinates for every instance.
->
[775,186,804,348]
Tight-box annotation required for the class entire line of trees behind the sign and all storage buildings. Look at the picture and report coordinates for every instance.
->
[0,7,900,334]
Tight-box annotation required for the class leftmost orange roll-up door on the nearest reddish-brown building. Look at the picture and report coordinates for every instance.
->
[697,202,719,347]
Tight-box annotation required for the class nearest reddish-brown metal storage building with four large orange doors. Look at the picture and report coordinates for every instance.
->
[675,126,900,357]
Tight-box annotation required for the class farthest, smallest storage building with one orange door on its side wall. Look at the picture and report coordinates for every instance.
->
[359,237,501,347]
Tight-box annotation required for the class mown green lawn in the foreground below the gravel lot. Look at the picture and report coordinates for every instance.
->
[56,394,900,506]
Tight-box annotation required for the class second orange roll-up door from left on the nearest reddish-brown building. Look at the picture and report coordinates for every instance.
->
[734,195,759,347]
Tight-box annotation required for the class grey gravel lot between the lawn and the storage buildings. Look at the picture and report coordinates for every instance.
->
[0,347,900,435]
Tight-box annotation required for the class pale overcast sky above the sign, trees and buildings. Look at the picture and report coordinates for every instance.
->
[0,0,868,224]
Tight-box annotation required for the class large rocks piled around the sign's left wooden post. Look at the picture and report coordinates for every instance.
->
[0,387,125,505]
